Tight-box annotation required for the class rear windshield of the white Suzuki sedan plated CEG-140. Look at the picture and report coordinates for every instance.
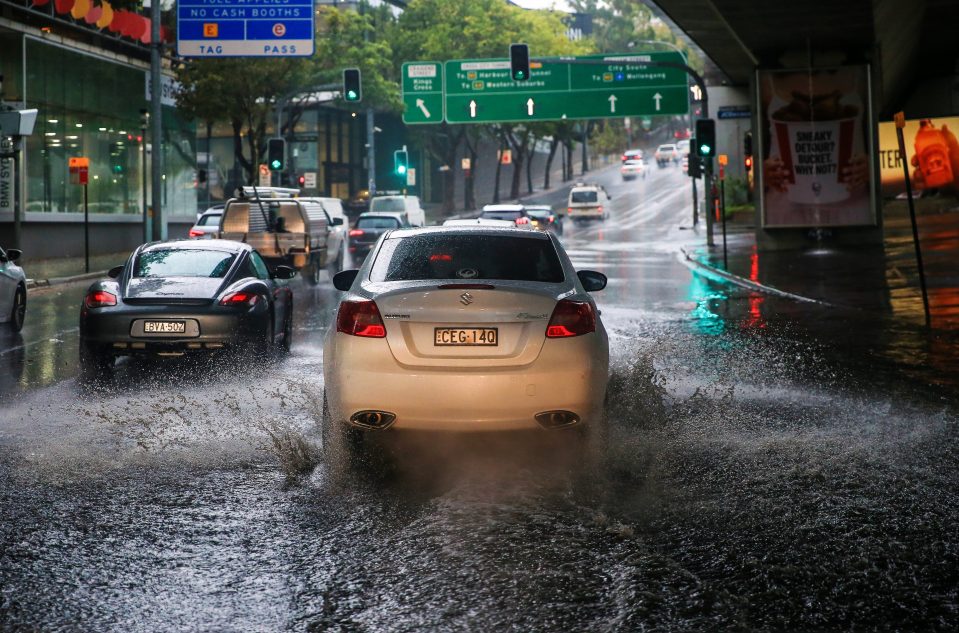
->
[370,233,564,283]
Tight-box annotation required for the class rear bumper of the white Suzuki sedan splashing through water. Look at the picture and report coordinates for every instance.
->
[324,332,609,432]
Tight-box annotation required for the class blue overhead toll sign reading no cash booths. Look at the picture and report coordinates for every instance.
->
[177,0,315,57]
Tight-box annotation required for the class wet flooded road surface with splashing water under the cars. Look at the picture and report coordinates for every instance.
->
[0,169,959,631]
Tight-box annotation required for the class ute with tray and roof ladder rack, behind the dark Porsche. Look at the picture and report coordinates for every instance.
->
[217,190,346,284]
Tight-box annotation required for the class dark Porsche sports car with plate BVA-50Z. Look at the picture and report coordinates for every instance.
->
[80,240,296,378]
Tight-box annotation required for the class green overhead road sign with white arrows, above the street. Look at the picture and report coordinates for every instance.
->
[402,51,689,125]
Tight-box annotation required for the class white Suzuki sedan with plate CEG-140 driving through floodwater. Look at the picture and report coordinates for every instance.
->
[322,226,609,454]
